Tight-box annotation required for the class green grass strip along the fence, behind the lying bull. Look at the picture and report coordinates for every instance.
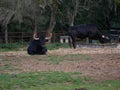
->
[0,42,69,52]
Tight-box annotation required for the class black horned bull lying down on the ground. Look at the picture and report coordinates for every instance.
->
[27,36,47,55]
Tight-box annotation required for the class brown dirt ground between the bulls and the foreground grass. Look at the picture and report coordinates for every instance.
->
[0,48,120,81]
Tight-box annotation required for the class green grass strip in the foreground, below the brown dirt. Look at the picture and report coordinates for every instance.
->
[0,72,120,90]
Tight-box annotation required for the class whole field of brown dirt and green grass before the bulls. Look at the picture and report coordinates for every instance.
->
[0,44,120,90]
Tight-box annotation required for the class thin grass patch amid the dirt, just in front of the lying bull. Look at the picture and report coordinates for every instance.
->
[36,54,92,64]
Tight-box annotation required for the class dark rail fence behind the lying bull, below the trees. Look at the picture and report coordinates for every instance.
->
[0,32,65,42]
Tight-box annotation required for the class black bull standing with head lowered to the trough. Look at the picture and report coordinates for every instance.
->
[69,24,109,48]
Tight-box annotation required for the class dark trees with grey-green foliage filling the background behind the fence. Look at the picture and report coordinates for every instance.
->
[0,0,120,42]
